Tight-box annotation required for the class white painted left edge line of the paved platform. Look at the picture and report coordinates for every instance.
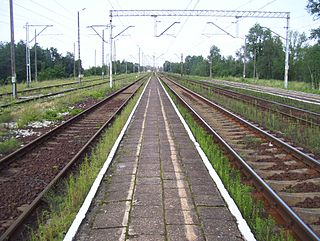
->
[63,77,151,241]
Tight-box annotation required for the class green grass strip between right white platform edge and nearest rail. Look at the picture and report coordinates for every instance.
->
[165,82,294,241]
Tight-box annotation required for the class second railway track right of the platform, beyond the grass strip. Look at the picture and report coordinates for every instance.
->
[171,76,320,127]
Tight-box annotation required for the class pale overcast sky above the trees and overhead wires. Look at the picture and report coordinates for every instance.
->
[0,0,320,68]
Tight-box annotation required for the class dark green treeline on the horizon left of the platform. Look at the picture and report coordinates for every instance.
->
[0,41,145,85]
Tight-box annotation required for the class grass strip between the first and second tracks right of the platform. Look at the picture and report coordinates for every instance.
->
[176,77,320,155]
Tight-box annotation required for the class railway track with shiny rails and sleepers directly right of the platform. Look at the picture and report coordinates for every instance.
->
[162,74,320,240]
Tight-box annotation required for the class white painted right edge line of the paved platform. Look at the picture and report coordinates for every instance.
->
[159,78,256,241]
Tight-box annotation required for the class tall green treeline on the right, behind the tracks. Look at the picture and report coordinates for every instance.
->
[163,24,320,89]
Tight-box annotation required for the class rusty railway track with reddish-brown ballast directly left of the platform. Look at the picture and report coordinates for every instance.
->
[0,77,146,240]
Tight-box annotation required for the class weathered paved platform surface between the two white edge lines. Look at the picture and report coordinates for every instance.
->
[75,78,243,241]
